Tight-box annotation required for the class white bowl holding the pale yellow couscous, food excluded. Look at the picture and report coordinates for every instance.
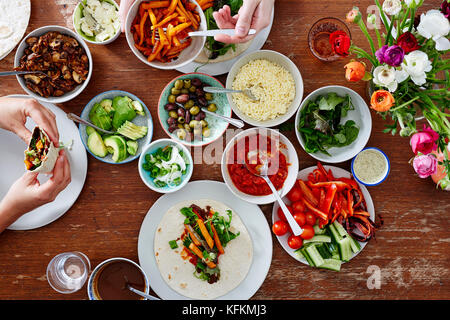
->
[226,50,303,127]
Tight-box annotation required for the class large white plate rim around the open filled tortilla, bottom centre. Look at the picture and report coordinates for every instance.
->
[138,180,272,300]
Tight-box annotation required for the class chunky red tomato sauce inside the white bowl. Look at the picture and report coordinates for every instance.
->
[227,134,289,196]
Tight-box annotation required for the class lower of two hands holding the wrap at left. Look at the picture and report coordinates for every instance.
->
[0,150,71,232]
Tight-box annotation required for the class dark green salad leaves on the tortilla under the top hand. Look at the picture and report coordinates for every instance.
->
[204,0,243,60]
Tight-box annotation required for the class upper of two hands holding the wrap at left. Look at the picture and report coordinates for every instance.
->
[0,97,59,147]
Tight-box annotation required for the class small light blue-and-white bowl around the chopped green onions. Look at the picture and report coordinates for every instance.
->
[138,139,194,193]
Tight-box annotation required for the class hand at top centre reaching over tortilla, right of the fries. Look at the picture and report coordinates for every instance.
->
[213,0,275,43]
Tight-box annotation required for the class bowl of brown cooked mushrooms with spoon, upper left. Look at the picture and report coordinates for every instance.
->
[14,26,93,103]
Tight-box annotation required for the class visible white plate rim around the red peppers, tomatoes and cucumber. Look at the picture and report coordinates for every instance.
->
[272,165,375,265]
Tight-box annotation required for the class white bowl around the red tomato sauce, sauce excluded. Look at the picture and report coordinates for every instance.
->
[221,128,299,204]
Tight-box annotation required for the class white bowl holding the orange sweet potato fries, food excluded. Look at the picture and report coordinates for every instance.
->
[125,0,207,70]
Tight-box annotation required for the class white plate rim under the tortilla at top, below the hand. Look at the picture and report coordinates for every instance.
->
[176,9,275,76]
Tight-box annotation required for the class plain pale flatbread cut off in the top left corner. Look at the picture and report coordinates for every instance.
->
[0,0,31,59]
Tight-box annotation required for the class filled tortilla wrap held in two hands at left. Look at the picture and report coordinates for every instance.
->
[24,127,59,173]
